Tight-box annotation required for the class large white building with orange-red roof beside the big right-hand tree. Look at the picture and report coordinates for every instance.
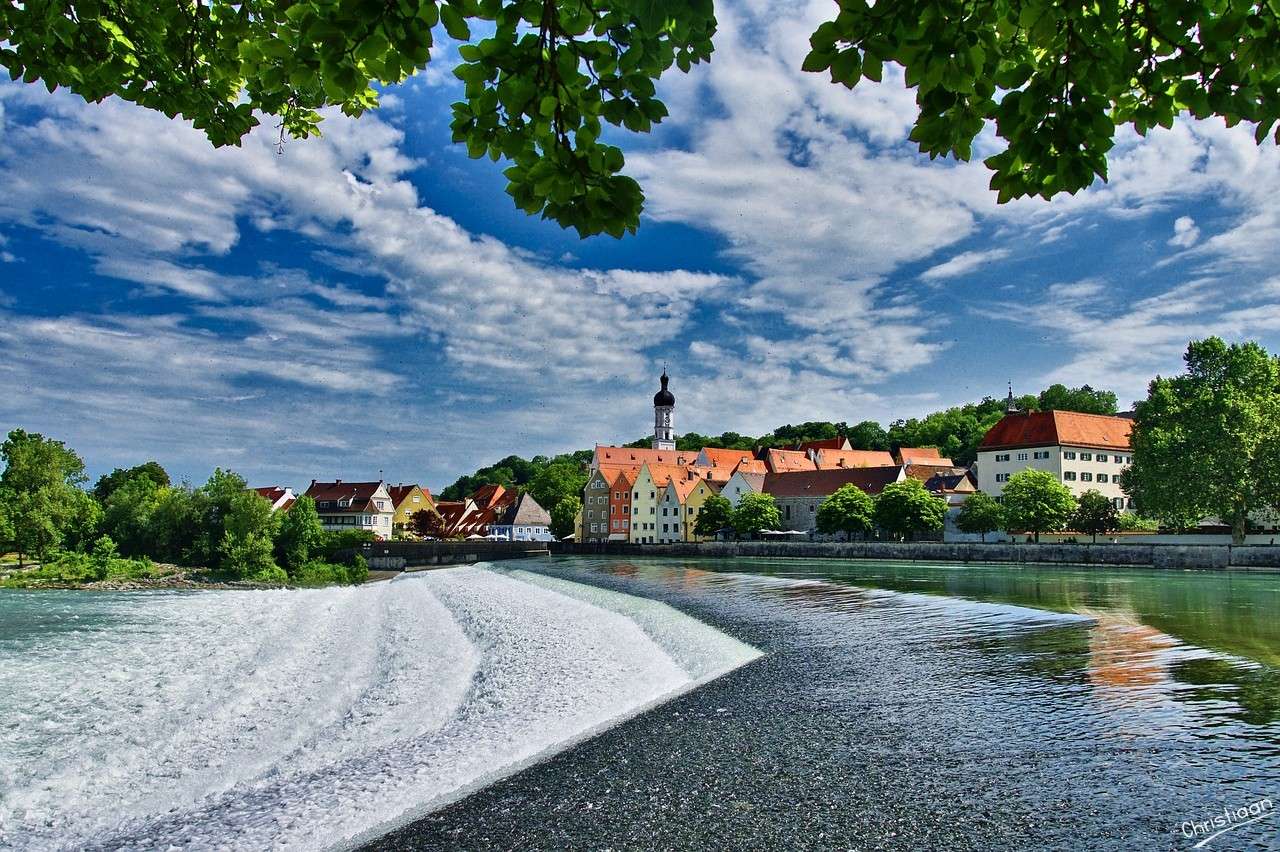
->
[977,411,1133,509]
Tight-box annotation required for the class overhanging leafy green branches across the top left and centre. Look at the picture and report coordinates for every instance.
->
[0,0,716,237]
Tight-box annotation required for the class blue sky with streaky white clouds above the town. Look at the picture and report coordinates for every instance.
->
[0,0,1280,489]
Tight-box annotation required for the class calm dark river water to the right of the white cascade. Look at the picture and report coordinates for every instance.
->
[365,549,1280,851]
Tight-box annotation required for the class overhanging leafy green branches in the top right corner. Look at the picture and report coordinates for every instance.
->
[803,0,1280,202]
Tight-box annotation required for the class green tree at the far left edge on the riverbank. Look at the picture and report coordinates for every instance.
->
[0,429,99,562]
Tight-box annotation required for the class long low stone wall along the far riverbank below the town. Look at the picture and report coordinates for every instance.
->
[550,541,1280,571]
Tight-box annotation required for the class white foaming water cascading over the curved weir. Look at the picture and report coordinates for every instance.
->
[0,567,758,849]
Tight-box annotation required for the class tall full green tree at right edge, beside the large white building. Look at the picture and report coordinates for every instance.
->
[1120,338,1280,544]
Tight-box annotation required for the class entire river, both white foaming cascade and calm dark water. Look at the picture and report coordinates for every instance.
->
[0,558,1280,849]
